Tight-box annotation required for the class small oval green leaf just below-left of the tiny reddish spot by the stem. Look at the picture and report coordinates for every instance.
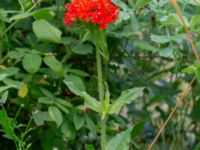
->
[73,112,85,130]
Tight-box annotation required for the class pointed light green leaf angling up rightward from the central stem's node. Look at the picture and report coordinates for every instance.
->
[109,88,144,114]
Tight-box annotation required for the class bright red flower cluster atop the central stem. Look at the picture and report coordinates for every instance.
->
[64,0,119,30]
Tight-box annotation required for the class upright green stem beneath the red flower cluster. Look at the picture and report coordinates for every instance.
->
[96,29,106,150]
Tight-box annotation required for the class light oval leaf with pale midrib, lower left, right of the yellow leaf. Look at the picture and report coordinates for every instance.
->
[48,106,63,127]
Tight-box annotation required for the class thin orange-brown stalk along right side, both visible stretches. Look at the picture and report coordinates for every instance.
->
[148,0,200,150]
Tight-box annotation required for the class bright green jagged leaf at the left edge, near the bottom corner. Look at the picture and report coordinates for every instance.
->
[0,109,20,142]
